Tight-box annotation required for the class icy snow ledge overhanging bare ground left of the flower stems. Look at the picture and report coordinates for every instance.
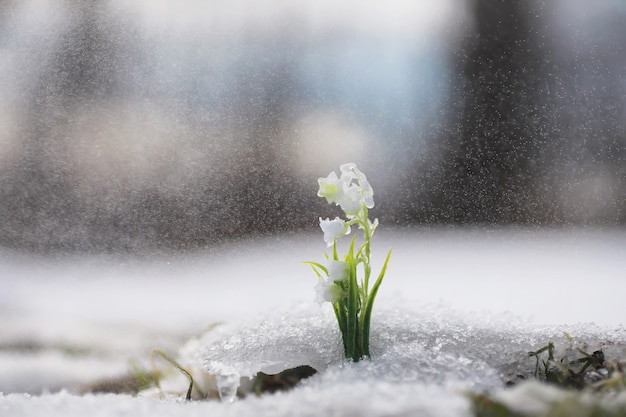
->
[181,304,343,401]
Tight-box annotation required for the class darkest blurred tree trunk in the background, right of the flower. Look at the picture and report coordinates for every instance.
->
[430,0,550,223]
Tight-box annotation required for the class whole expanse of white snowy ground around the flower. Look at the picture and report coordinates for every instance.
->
[0,227,626,417]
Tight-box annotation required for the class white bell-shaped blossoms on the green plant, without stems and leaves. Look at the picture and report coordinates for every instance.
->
[315,163,378,304]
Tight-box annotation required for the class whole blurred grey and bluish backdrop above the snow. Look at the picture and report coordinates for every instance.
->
[0,0,626,252]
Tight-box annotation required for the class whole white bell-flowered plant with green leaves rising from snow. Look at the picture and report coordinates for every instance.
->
[305,163,391,362]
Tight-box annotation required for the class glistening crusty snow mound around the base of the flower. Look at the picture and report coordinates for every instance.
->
[181,303,625,401]
